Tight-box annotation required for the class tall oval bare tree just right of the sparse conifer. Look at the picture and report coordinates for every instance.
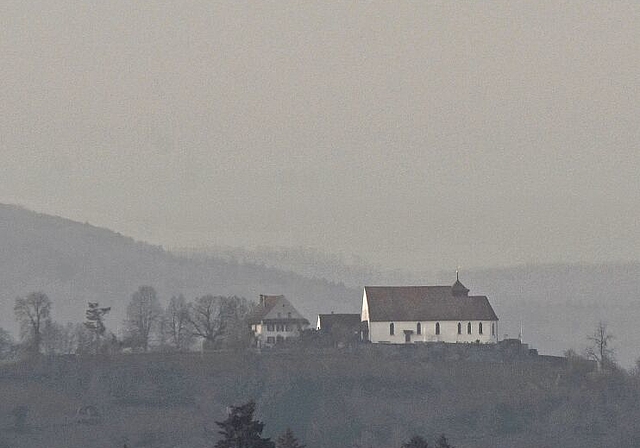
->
[124,286,162,352]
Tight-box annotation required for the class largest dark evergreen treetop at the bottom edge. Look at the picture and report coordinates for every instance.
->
[215,401,275,448]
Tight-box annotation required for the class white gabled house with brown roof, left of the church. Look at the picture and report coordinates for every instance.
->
[248,294,309,347]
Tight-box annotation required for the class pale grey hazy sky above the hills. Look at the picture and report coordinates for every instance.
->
[0,0,640,269]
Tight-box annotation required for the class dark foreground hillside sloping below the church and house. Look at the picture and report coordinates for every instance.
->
[0,352,640,448]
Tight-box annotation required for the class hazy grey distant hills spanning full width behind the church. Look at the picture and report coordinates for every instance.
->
[0,205,640,366]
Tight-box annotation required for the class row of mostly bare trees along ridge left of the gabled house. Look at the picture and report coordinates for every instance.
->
[0,286,255,359]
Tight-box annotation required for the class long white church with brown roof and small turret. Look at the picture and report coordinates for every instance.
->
[361,278,498,344]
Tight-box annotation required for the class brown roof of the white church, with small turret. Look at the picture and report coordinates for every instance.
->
[364,288,498,322]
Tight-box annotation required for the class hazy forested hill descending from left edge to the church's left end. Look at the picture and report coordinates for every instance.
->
[0,205,360,330]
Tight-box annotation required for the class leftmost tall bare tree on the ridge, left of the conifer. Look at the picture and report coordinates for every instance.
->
[13,292,51,353]
